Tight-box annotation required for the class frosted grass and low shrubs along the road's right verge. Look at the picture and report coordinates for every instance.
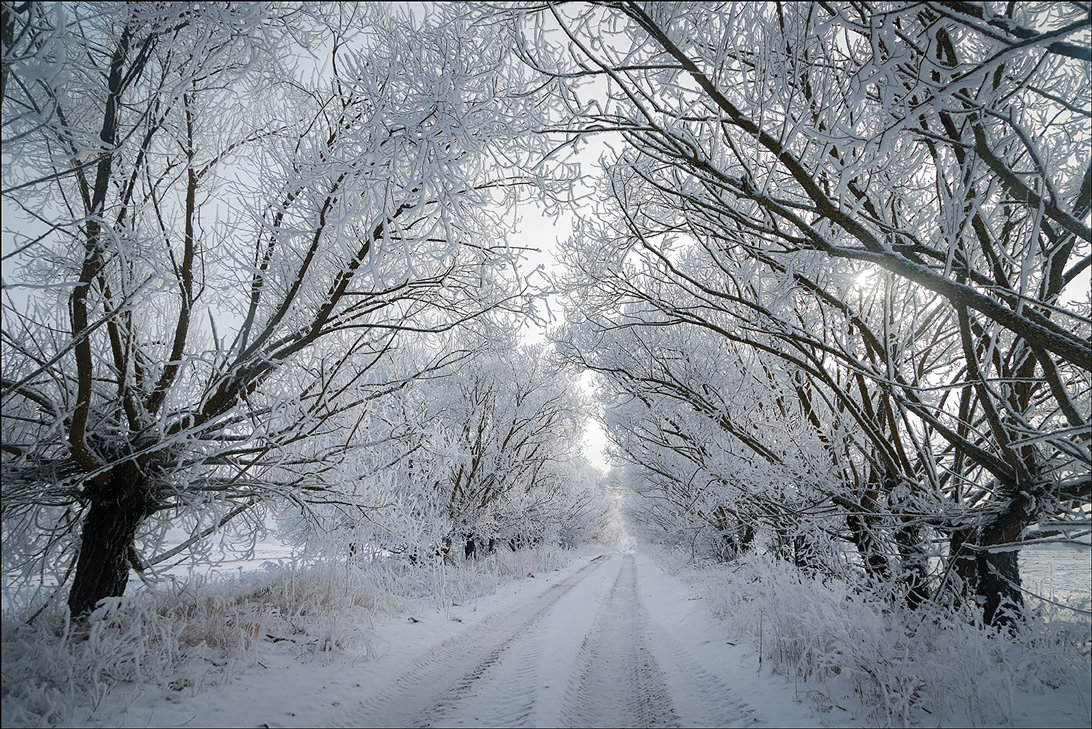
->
[674,553,1090,726]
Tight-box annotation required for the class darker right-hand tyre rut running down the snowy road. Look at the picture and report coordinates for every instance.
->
[561,554,679,727]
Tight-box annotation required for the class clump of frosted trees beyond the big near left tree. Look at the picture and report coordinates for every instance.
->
[273,332,607,564]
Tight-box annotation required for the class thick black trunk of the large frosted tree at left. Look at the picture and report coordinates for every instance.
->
[68,464,149,617]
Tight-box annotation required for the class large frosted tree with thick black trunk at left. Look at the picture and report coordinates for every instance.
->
[2,2,554,614]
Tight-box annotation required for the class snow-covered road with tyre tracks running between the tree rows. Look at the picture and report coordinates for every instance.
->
[327,554,815,727]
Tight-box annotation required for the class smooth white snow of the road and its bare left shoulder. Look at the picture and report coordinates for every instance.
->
[72,552,821,727]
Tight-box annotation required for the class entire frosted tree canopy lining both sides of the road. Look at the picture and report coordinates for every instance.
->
[0,0,1092,623]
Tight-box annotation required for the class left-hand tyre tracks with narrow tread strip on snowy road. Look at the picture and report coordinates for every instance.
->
[334,555,606,727]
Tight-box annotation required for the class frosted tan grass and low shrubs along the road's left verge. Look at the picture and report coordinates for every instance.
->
[3,563,399,726]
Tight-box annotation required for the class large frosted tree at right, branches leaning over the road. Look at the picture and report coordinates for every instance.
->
[520,2,1092,622]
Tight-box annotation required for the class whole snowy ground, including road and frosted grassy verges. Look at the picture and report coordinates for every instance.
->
[3,545,1092,727]
